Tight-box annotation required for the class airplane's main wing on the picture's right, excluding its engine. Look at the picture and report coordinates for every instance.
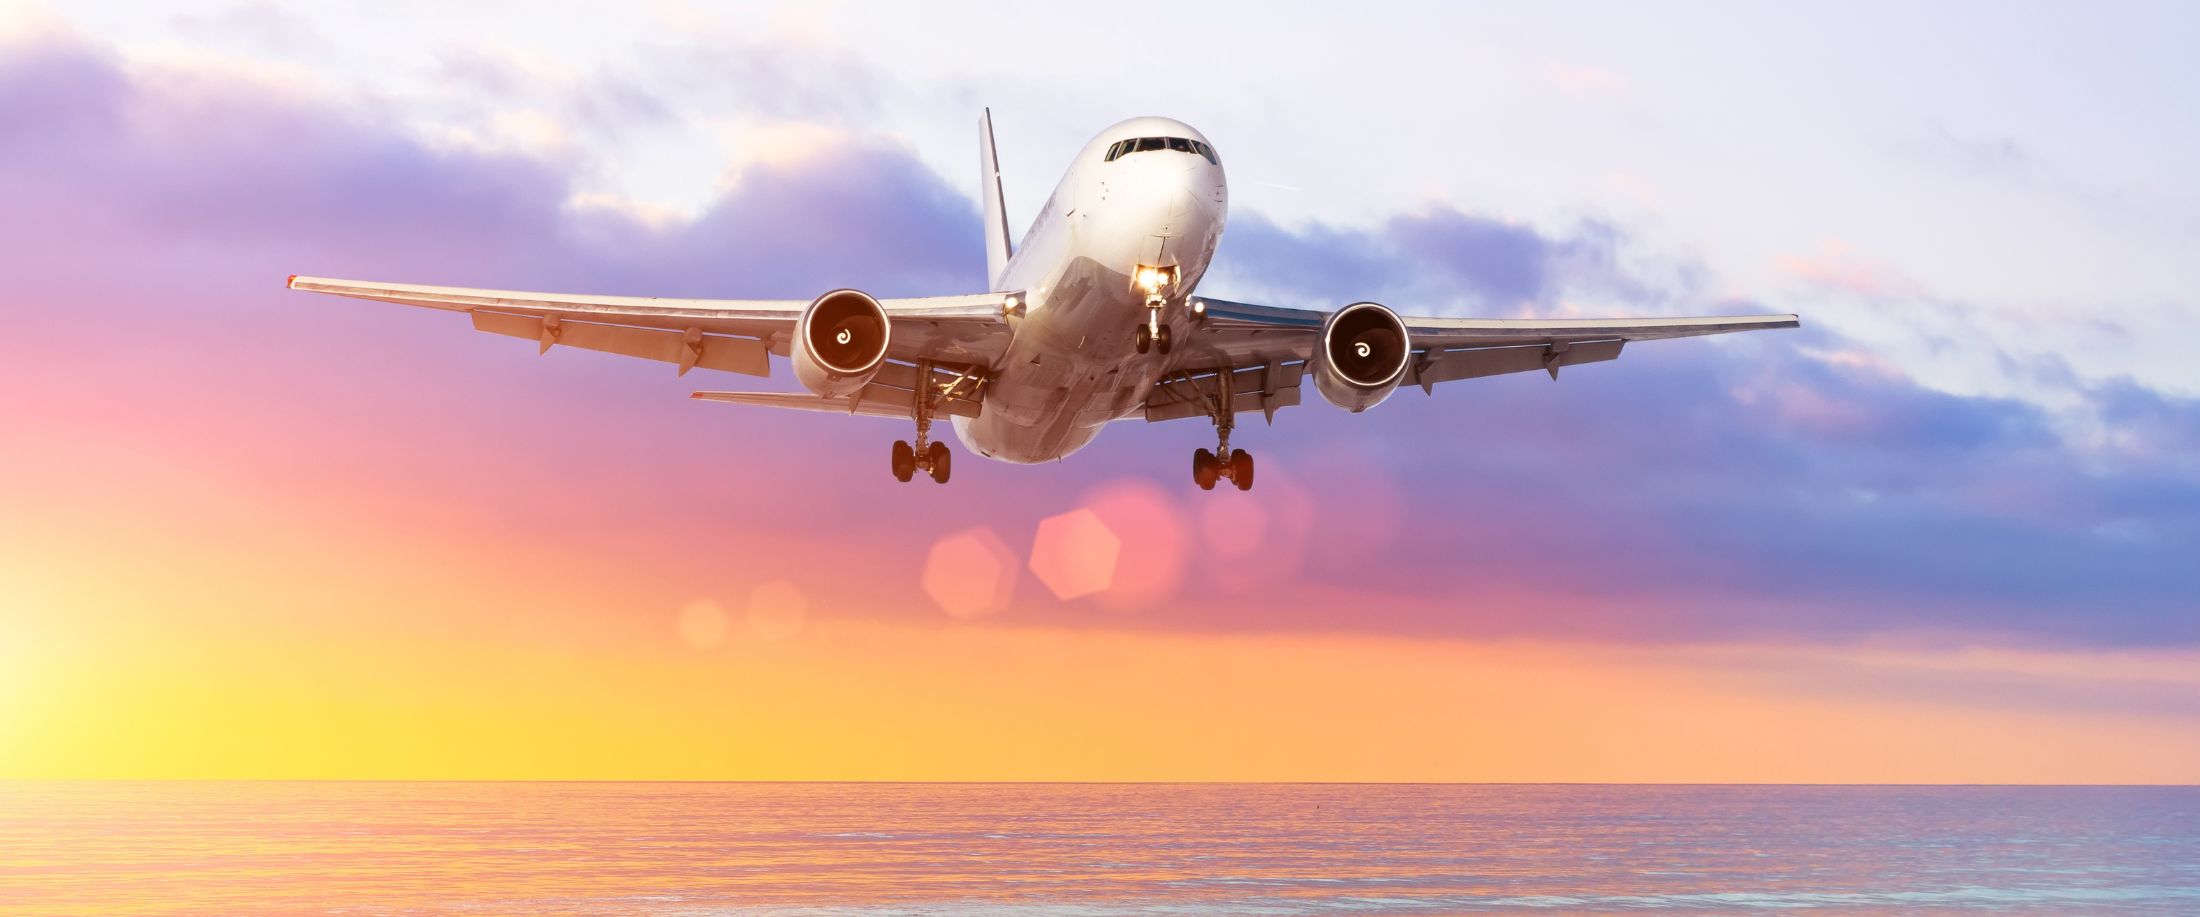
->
[1144,297,1800,422]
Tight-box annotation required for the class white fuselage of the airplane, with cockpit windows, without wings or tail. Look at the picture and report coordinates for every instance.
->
[955,119,1230,464]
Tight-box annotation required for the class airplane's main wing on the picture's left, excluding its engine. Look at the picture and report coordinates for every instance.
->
[290,277,1014,376]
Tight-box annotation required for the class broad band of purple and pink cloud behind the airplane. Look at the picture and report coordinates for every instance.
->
[0,30,2200,644]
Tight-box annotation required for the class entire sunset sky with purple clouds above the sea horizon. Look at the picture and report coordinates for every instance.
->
[0,2,2200,783]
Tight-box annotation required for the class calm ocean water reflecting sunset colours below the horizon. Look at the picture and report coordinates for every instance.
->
[0,783,2200,917]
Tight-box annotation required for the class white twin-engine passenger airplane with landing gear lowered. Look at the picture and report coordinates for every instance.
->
[288,110,1797,490]
